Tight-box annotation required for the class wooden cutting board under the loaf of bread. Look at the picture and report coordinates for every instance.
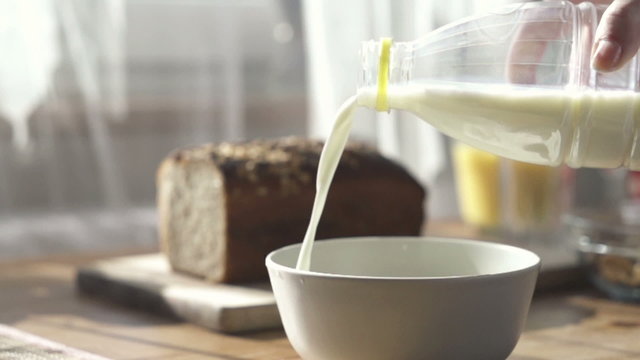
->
[76,254,282,333]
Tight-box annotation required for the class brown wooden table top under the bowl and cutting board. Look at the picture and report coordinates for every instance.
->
[0,253,640,360]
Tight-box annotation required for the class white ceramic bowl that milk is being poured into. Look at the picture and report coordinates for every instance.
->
[266,237,540,360]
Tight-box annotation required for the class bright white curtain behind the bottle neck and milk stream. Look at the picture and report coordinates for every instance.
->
[303,0,507,217]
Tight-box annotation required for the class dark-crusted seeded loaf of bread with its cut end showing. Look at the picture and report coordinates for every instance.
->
[157,138,426,283]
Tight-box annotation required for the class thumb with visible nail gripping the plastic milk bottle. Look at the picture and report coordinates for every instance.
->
[591,0,640,71]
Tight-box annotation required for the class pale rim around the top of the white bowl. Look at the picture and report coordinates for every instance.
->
[265,236,541,281]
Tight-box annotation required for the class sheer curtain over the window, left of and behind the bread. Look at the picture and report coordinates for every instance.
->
[0,0,306,262]
